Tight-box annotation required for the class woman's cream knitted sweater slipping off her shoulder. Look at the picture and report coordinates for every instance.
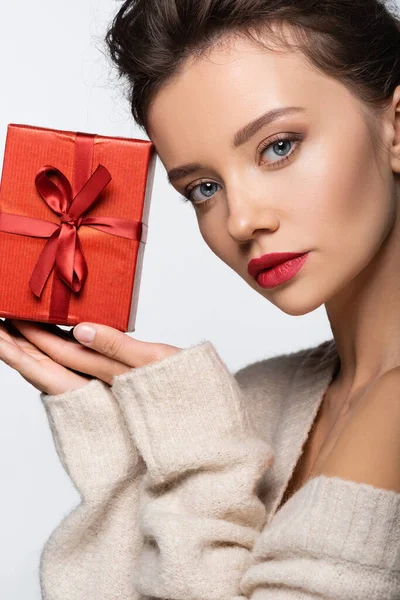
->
[40,340,400,600]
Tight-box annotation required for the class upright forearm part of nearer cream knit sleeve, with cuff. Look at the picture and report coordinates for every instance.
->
[112,341,274,600]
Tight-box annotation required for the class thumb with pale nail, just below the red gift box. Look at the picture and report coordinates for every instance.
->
[74,323,176,368]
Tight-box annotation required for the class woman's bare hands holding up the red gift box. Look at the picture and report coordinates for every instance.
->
[0,319,181,395]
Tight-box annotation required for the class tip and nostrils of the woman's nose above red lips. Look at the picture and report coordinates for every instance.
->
[227,189,279,243]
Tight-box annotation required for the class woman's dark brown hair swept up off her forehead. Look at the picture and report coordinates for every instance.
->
[106,0,400,142]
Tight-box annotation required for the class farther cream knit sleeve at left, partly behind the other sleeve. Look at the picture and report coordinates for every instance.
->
[39,379,145,600]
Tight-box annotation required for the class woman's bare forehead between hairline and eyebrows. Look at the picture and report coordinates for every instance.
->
[148,32,356,158]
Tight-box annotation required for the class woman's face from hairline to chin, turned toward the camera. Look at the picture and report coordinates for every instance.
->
[149,30,400,315]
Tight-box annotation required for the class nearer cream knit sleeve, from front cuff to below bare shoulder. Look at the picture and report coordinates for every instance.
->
[112,342,400,600]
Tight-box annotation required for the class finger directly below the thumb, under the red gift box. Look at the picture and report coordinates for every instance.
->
[12,319,129,384]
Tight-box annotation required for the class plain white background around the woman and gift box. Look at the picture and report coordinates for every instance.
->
[0,0,390,600]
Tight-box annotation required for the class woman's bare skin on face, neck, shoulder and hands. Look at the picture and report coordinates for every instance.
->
[0,24,400,492]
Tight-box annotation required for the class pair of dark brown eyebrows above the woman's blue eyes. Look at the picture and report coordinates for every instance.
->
[167,106,306,184]
